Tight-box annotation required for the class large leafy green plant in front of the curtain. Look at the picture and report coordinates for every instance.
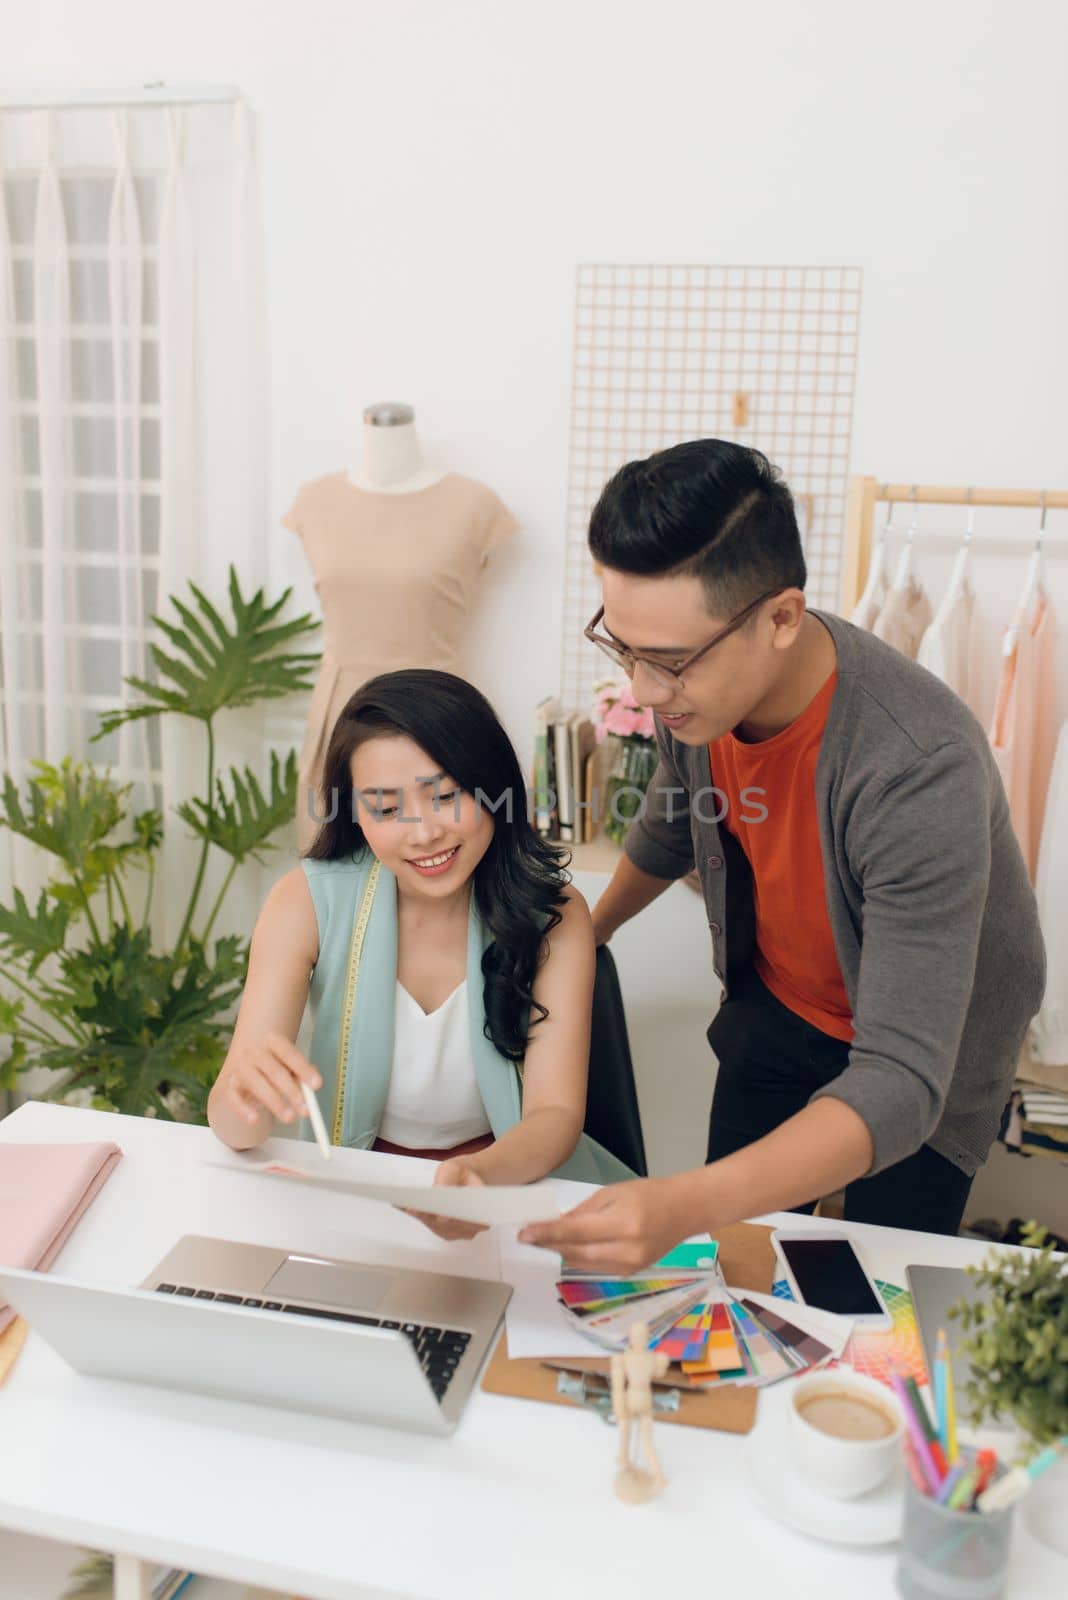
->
[0,568,318,1120]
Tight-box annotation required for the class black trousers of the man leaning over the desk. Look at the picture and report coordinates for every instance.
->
[708,968,972,1234]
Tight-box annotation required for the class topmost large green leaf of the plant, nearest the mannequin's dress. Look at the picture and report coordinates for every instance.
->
[94,566,320,739]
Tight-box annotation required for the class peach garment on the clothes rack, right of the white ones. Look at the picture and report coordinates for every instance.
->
[990,594,1057,883]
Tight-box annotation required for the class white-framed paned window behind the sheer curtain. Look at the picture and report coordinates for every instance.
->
[3,171,161,806]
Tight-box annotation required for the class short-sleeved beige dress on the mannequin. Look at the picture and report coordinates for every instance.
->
[281,472,518,851]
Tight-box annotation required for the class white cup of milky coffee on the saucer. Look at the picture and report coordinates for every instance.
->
[790,1370,903,1499]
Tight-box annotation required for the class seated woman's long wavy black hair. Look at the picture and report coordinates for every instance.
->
[307,667,569,1061]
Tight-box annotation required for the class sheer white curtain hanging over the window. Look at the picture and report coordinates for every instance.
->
[0,101,269,938]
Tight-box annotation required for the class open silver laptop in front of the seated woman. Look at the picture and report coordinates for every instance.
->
[0,1234,512,1434]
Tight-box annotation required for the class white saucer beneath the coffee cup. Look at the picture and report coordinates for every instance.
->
[745,1390,905,1544]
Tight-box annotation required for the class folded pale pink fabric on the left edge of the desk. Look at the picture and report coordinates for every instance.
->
[0,1142,123,1333]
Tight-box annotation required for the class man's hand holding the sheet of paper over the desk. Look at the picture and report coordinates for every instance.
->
[520,1178,694,1275]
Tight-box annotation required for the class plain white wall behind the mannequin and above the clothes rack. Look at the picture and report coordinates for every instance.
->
[0,0,1068,768]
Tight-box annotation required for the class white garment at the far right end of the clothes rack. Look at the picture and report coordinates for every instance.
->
[1020,722,1068,1075]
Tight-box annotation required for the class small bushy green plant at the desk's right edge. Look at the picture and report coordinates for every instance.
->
[950,1222,1068,1446]
